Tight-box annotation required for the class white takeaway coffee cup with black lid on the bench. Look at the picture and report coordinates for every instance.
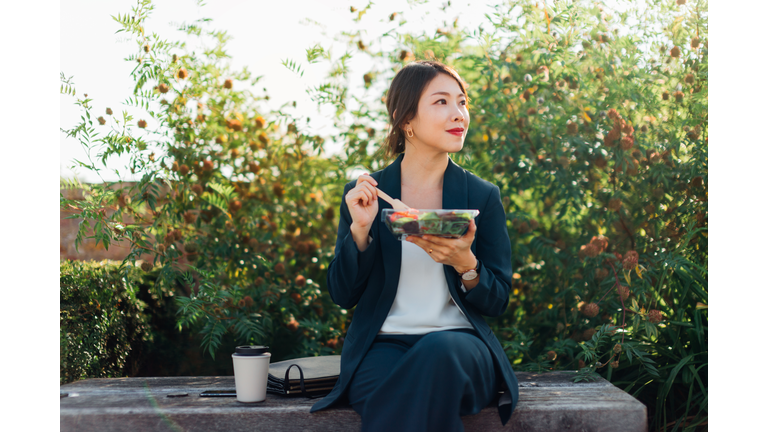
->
[232,345,271,402]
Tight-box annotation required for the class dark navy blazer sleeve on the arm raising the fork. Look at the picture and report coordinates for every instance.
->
[327,183,378,309]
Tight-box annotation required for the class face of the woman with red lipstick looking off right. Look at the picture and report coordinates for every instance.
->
[404,73,469,153]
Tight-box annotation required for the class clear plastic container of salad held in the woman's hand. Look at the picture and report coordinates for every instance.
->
[381,209,480,240]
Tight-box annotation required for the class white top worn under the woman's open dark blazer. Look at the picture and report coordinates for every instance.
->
[379,241,473,334]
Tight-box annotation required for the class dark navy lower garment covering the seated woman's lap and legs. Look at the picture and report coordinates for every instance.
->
[347,329,498,432]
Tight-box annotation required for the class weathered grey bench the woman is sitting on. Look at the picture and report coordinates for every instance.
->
[59,372,647,432]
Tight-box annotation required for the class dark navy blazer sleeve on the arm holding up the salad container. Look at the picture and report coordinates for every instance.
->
[465,185,512,317]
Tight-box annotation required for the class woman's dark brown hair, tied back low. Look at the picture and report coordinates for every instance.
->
[386,60,469,157]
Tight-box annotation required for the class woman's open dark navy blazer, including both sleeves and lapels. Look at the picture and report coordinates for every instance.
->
[310,154,518,424]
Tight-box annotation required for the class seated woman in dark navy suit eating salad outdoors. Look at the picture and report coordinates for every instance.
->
[311,61,518,431]
